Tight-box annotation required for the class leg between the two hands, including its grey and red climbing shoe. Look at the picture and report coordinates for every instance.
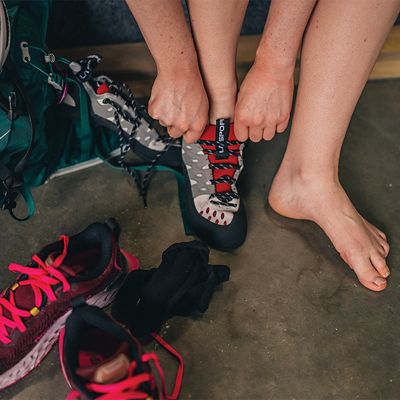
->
[182,0,247,251]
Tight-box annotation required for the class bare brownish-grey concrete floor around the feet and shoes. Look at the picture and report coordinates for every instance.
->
[0,80,400,400]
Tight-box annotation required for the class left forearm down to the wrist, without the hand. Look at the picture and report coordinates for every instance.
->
[126,0,197,73]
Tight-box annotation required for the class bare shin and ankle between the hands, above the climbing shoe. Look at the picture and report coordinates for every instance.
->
[188,0,248,123]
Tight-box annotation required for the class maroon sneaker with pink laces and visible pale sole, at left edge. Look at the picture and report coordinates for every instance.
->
[0,221,138,390]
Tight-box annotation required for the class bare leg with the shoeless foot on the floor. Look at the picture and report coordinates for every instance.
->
[269,0,400,291]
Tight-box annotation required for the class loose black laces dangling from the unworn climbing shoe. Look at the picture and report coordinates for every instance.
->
[103,82,173,207]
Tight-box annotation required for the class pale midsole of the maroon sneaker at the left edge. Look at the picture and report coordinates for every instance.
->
[0,249,138,390]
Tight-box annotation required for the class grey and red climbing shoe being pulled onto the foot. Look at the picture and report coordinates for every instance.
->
[182,119,247,251]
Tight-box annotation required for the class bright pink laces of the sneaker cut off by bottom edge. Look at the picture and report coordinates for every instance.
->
[66,353,170,400]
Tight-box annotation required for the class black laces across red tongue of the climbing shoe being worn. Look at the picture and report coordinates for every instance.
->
[197,139,242,207]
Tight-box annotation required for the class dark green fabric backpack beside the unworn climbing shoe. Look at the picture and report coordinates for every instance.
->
[0,0,118,220]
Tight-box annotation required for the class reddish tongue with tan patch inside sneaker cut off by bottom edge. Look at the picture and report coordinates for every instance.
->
[76,342,130,384]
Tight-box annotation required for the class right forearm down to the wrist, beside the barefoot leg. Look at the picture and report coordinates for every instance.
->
[256,0,317,74]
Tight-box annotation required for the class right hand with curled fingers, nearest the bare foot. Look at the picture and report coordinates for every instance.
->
[235,62,294,142]
